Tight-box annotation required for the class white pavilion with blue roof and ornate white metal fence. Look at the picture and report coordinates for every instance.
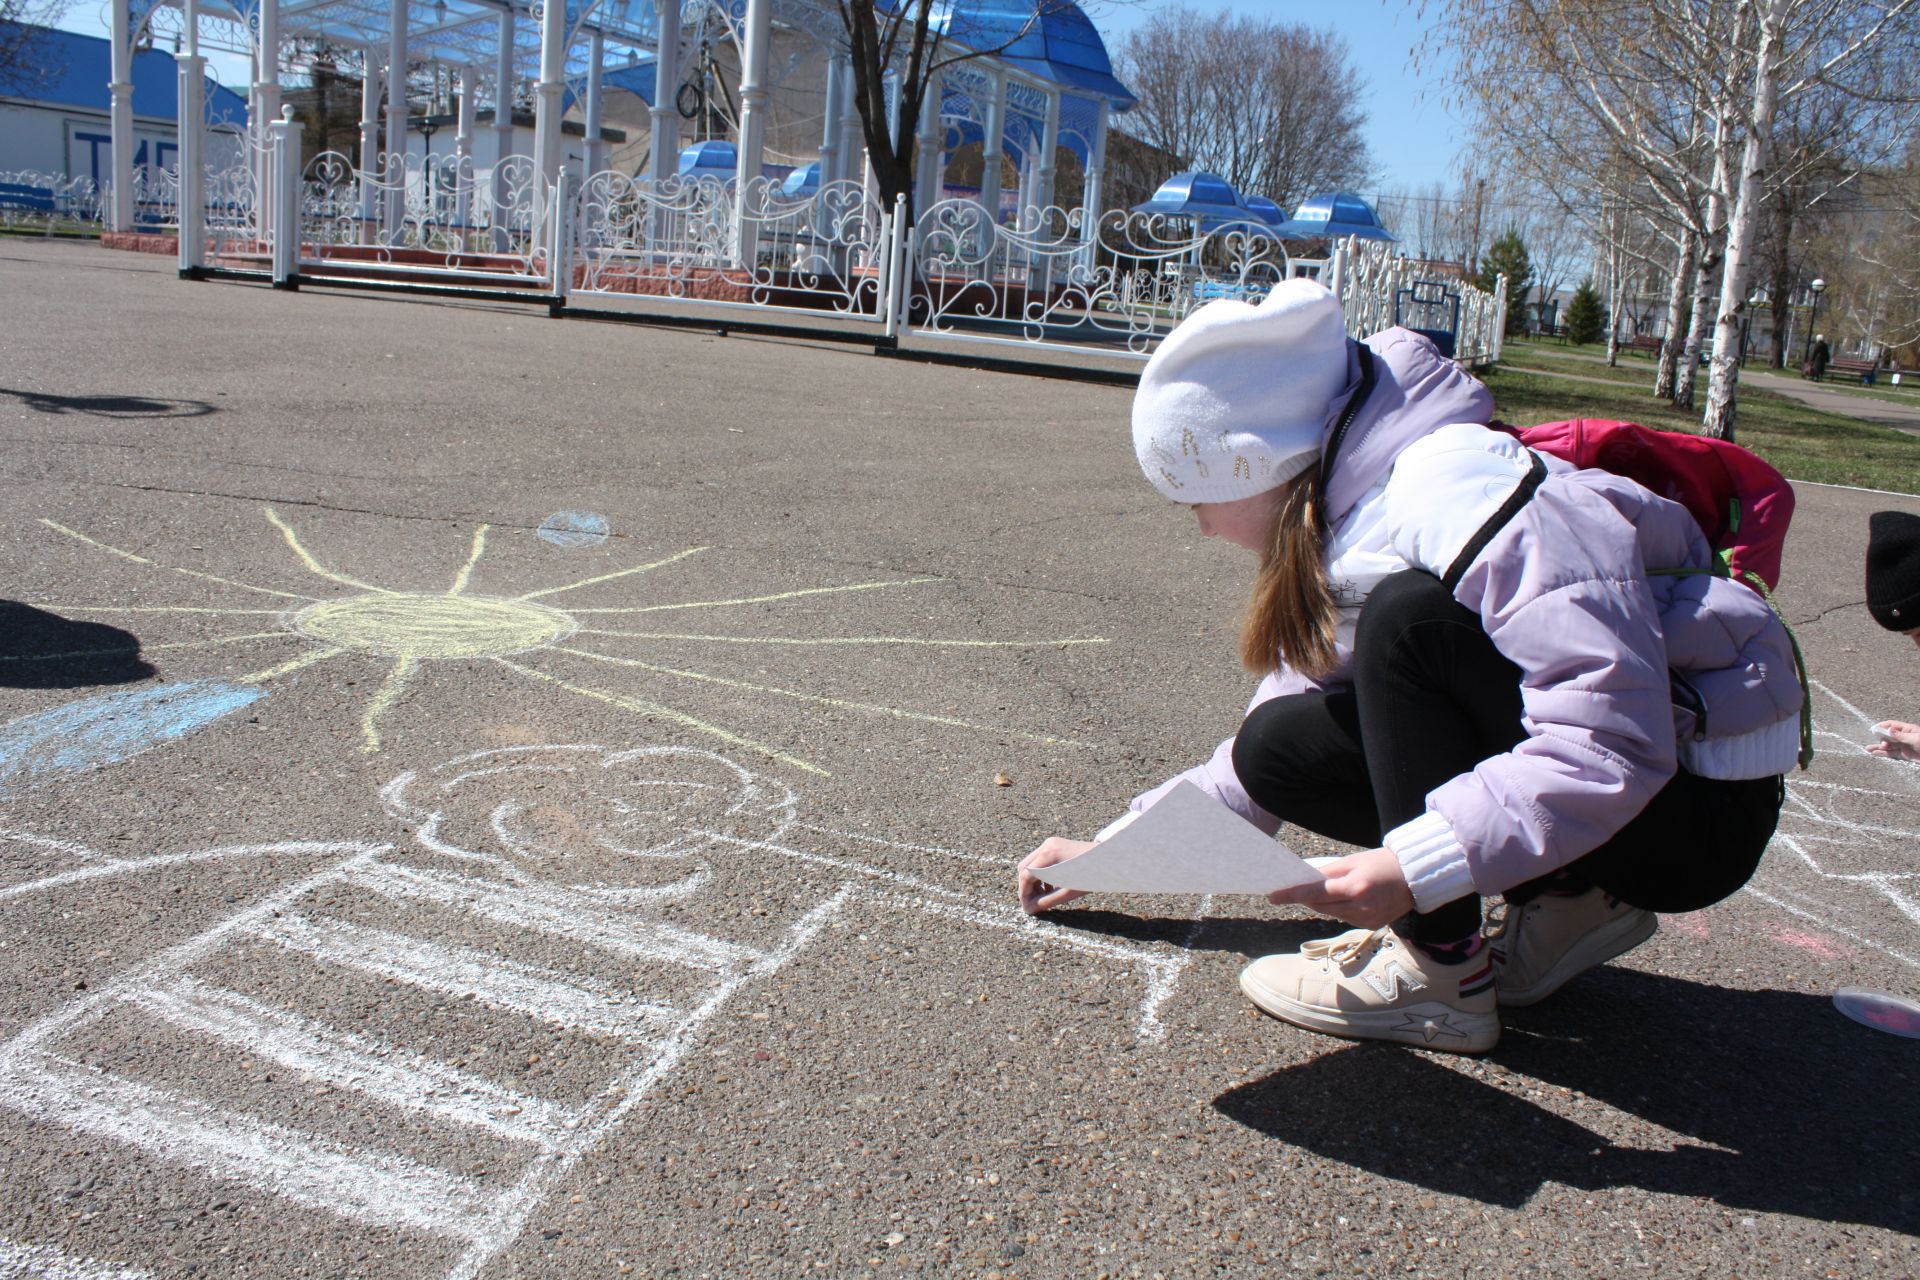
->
[67,0,1503,372]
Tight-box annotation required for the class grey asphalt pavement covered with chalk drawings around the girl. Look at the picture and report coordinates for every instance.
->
[11,240,1920,1280]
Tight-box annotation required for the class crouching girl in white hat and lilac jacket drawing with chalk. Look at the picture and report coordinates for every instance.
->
[1018,278,1803,1054]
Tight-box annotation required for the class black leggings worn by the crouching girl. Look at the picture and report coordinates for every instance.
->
[1233,570,1784,942]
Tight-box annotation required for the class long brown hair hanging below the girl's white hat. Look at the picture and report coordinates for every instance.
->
[1240,462,1340,677]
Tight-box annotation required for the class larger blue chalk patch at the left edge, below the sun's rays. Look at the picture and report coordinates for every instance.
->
[0,679,267,796]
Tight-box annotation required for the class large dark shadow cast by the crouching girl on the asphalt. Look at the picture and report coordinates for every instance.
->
[1213,969,1920,1232]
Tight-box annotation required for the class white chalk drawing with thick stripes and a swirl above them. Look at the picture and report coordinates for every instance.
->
[0,745,1187,1280]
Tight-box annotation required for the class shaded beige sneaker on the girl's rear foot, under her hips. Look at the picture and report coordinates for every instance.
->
[1490,889,1661,1007]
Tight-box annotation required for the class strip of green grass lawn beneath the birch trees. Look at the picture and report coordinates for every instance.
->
[1482,364,1920,493]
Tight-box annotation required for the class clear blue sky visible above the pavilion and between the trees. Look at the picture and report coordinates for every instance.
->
[60,0,1465,200]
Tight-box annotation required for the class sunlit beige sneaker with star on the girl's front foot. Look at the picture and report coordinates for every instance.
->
[1240,929,1500,1054]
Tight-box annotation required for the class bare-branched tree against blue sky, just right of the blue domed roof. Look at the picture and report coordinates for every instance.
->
[1117,4,1373,209]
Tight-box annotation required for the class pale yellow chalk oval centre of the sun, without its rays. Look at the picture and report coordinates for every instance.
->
[288,593,578,658]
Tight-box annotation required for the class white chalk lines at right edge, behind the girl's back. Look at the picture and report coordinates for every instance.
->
[1745,681,1920,969]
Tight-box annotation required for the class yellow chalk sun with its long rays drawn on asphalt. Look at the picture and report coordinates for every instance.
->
[19,507,1106,775]
